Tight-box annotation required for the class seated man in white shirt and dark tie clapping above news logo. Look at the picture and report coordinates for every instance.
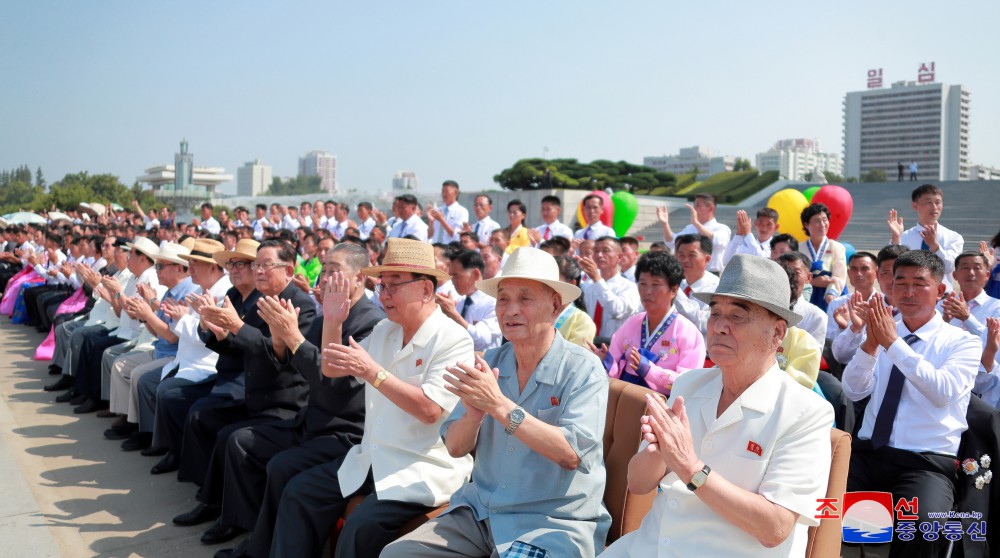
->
[843,250,982,557]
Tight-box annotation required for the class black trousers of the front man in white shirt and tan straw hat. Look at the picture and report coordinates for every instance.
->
[264,470,433,558]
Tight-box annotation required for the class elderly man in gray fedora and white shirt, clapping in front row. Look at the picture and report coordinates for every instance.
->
[602,254,833,557]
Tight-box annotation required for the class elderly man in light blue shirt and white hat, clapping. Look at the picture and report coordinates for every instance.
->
[382,247,611,557]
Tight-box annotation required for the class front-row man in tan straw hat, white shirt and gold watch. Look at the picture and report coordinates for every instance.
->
[254,238,473,558]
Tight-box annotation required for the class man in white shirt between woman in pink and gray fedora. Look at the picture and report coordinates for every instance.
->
[674,234,719,335]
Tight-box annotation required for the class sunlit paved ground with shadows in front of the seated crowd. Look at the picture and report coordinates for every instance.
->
[0,317,238,558]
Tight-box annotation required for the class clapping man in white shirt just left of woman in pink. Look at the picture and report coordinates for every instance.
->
[577,237,641,337]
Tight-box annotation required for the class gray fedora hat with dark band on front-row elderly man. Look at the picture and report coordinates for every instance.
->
[694,254,802,327]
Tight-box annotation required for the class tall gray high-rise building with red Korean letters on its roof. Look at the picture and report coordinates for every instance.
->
[844,80,969,180]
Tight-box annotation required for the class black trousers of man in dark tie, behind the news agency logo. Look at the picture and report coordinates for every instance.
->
[847,446,957,558]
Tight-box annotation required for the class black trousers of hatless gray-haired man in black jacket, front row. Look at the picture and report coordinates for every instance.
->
[221,419,351,531]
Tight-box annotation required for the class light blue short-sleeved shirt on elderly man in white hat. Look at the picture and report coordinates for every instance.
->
[441,332,611,556]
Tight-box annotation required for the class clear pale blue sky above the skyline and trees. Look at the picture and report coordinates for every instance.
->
[0,0,1000,195]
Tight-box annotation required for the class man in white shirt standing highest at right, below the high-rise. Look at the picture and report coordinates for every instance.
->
[889,184,965,292]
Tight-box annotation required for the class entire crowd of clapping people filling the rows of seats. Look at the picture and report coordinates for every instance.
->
[0,180,1000,557]
